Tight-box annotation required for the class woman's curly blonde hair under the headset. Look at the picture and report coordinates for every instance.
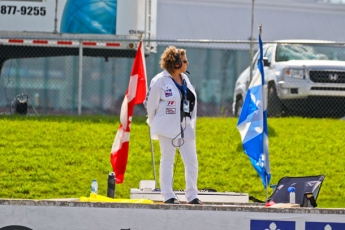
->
[159,46,187,72]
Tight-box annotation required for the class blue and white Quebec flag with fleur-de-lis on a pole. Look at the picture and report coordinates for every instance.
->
[237,35,271,188]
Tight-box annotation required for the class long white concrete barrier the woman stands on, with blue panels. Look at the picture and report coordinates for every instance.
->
[0,199,345,230]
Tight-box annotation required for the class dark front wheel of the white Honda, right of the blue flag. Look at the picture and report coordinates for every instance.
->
[267,84,282,117]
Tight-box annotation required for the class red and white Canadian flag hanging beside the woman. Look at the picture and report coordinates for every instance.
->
[110,41,147,184]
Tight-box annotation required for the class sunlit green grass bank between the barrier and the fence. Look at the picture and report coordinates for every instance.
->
[0,116,345,208]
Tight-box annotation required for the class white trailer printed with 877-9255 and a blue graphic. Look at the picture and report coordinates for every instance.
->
[0,0,157,64]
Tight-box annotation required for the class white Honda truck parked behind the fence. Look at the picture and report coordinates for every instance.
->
[233,40,345,117]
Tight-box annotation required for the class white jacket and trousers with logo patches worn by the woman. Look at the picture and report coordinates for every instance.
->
[144,70,198,202]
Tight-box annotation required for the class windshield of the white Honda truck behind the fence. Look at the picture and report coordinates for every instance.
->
[276,44,345,62]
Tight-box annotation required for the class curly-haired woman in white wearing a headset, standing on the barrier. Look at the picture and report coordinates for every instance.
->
[144,46,202,204]
